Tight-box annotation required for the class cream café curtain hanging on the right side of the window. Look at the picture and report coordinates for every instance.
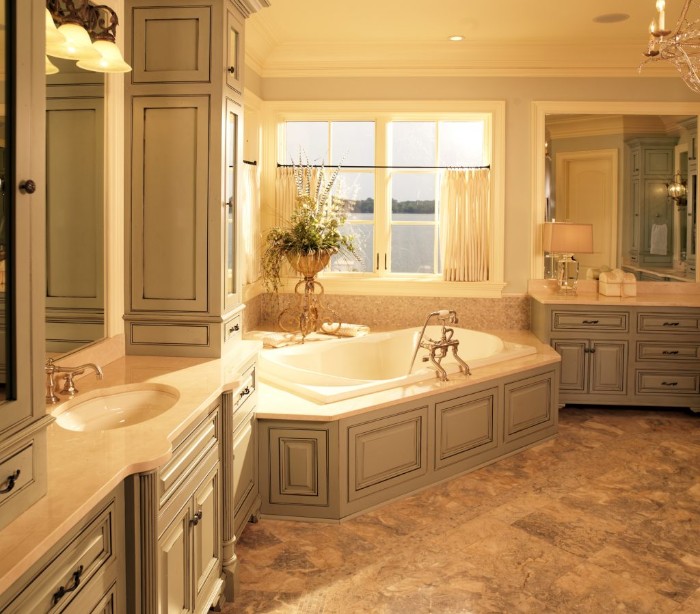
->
[440,169,491,281]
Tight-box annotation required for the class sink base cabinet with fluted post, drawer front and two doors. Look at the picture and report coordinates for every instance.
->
[126,401,223,614]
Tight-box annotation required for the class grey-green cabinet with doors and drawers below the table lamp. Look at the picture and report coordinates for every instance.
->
[532,299,700,410]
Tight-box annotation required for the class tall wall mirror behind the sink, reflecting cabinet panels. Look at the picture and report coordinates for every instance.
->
[46,57,105,356]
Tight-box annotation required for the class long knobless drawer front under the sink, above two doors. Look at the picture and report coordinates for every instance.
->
[158,406,219,507]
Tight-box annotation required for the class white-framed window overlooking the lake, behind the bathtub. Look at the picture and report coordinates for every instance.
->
[283,114,489,277]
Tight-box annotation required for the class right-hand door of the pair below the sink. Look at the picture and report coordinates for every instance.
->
[190,464,221,611]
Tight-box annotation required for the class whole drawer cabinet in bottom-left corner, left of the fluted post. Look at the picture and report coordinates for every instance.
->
[0,485,128,614]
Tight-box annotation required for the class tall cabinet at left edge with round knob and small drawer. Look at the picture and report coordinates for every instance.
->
[0,0,51,528]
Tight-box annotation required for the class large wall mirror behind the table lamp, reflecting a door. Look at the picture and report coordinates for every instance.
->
[540,113,697,281]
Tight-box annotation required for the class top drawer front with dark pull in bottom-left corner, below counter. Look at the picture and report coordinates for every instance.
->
[3,501,116,614]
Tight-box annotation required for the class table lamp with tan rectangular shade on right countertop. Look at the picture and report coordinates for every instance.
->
[543,222,593,294]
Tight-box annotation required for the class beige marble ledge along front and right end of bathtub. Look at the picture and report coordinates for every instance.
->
[256,330,561,422]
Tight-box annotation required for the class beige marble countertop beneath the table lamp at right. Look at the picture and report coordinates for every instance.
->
[528,279,700,307]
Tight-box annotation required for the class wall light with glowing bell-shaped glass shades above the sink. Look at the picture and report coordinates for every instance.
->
[45,0,131,74]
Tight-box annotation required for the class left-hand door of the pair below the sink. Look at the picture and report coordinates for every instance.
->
[158,505,192,614]
